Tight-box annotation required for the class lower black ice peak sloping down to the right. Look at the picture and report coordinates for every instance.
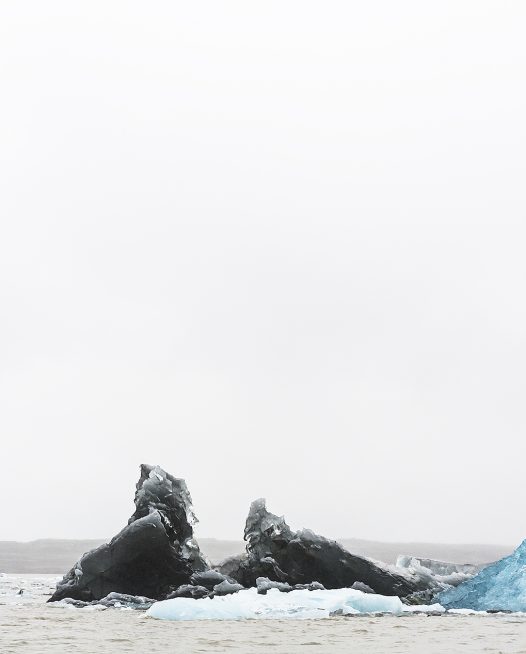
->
[218,499,422,597]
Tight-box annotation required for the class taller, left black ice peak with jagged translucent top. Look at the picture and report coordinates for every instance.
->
[49,464,208,602]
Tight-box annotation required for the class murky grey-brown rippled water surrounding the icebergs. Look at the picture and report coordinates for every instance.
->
[0,575,526,654]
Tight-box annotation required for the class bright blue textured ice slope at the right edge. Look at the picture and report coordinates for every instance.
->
[437,540,526,611]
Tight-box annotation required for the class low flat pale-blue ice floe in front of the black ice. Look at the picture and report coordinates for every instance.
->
[147,588,410,620]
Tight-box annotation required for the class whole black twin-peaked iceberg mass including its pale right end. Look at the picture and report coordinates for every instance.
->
[49,464,473,609]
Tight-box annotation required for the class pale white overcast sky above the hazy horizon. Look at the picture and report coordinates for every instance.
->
[0,0,526,544]
